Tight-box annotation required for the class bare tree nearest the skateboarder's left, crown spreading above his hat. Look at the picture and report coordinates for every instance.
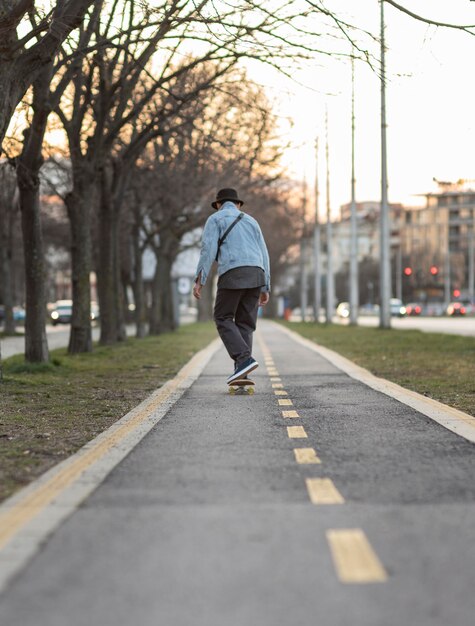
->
[138,72,280,333]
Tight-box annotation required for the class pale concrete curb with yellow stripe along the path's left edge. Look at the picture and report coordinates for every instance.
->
[0,339,221,592]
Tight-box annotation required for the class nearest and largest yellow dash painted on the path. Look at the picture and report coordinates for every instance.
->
[327,528,388,583]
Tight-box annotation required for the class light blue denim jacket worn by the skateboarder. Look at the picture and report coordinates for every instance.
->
[195,201,270,291]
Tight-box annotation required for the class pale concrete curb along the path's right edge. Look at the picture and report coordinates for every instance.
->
[273,322,475,443]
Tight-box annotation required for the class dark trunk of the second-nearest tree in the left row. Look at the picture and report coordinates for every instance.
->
[65,177,95,354]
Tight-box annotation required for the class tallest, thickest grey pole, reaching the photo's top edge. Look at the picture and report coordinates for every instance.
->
[379,0,391,328]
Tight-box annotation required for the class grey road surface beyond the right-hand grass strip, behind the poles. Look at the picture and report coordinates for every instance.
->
[343,316,475,337]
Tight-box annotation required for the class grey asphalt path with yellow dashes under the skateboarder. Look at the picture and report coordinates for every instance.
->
[0,322,475,626]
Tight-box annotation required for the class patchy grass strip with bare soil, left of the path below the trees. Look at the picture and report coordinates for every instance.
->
[0,323,216,501]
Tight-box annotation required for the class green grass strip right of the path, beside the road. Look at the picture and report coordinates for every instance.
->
[282,322,475,416]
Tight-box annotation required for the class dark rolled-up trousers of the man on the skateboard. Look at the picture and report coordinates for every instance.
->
[214,287,261,364]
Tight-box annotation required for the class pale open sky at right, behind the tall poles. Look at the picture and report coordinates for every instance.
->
[244,0,475,216]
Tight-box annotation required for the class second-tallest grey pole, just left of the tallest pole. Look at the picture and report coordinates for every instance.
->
[349,54,359,326]
